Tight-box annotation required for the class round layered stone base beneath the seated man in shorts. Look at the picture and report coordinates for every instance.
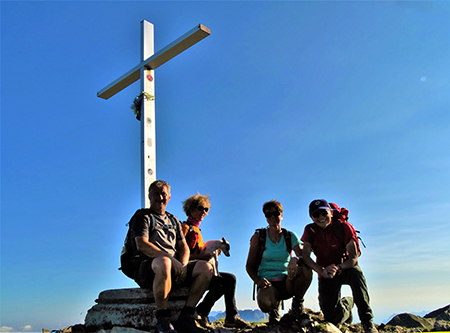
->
[84,288,189,332]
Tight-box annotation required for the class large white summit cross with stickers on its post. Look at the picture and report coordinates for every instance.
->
[97,20,211,207]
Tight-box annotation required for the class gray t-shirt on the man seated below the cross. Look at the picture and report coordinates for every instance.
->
[131,209,184,256]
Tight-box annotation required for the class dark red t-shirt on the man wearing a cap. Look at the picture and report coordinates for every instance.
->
[301,222,356,267]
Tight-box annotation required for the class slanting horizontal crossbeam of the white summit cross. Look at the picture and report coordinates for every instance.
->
[97,24,211,99]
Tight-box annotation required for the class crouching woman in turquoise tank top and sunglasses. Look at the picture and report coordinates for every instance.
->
[246,200,312,324]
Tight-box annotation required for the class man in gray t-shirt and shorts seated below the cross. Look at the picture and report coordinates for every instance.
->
[125,180,213,333]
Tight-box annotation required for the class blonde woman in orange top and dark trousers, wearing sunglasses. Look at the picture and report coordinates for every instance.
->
[181,194,250,328]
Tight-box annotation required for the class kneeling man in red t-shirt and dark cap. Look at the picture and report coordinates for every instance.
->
[301,199,378,333]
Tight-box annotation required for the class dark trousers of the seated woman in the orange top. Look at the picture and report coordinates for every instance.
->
[197,272,238,317]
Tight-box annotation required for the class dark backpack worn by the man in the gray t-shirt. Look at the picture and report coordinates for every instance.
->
[119,208,177,279]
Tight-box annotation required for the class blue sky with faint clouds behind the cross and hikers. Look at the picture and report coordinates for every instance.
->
[0,1,450,332]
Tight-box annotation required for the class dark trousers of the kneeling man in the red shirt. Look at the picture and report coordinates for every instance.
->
[319,266,373,325]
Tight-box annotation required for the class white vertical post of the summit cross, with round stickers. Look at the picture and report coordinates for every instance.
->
[141,20,156,208]
